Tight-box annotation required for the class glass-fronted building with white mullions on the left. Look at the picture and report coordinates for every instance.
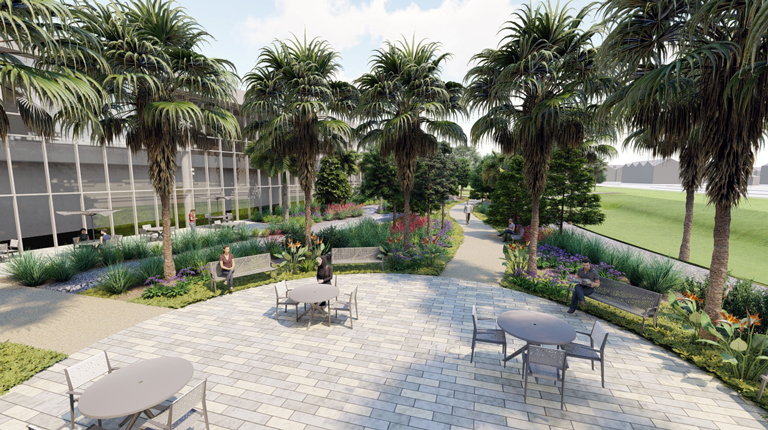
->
[0,103,304,249]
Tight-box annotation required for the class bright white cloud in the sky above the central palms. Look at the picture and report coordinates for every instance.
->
[240,0,517,81]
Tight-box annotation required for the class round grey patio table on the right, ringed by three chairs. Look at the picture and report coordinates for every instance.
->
[496,310,576,363]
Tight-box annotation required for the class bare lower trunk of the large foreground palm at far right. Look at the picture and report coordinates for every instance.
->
[699,204,731,339]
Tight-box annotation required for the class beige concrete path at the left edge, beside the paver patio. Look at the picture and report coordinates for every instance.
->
[0,280,170,354]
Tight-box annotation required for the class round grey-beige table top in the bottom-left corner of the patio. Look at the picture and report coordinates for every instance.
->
[78,357,194,430]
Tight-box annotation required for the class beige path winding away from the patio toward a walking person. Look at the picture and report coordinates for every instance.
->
[440,201,505,284]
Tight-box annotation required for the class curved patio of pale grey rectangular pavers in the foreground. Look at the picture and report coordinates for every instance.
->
[0,274,768,430]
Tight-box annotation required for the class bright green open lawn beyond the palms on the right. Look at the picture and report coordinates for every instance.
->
[588,187,768,284]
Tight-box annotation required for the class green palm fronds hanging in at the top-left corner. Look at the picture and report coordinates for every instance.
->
[0,0,105,141]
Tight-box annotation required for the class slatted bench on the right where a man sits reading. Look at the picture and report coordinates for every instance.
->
[568,276,661,334]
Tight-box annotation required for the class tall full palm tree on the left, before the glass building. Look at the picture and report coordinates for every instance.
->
[75,0,239,279]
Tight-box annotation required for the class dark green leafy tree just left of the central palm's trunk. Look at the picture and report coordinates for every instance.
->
[360,148,403,219]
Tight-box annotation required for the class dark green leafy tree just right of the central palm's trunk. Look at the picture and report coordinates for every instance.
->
[413,142,458,229]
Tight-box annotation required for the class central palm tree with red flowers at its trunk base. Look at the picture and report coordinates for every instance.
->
[355,40,467,244]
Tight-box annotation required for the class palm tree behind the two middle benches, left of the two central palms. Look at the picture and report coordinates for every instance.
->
[243,38,356,243]
